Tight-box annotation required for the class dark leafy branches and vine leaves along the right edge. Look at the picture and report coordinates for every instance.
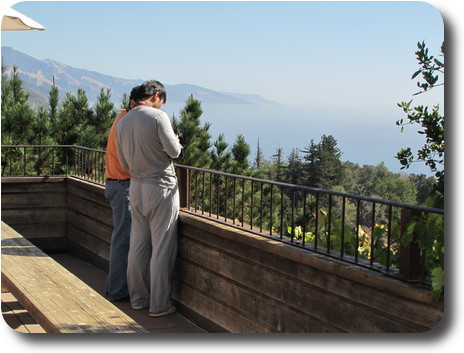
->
[396,42,445,298]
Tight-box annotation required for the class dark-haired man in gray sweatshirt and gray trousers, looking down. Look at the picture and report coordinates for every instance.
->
[116,80,182,317]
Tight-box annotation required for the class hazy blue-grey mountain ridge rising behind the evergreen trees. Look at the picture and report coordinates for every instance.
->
[2,46,275,106]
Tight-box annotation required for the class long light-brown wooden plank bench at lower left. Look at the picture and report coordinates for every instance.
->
[2,222,147,333]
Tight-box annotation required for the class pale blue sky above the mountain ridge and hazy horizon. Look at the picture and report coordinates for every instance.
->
[1,0,444,107]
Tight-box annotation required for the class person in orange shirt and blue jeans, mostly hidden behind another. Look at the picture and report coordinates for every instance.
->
[105,86,140,302]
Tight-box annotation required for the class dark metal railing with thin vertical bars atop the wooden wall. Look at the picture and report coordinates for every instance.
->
[2,146,444,281]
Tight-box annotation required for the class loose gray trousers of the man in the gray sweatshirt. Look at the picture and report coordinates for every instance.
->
[127,178,179,312]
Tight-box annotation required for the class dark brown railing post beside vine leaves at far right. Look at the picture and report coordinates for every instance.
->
[399,208,423,280]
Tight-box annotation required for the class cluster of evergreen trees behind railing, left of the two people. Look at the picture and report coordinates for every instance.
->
[2,66,117,175]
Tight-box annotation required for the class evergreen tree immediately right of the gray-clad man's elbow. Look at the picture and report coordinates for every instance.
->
[172,95,211,168]
